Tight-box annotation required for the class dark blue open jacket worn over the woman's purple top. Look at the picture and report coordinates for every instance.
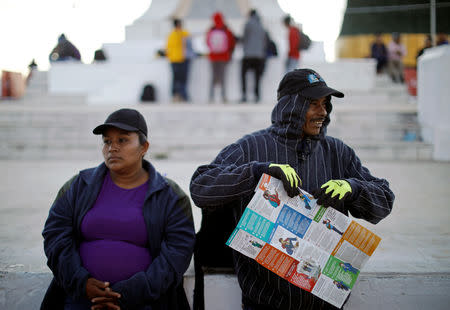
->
[41,161,195,309]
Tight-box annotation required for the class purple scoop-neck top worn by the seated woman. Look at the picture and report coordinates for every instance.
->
[80,172,152,283]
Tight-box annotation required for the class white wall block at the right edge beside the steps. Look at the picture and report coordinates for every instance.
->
[417,45,450,161]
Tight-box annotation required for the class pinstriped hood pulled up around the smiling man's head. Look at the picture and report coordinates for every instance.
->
[269,94,332,140]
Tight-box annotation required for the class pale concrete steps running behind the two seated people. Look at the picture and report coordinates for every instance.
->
[0,101,431,161]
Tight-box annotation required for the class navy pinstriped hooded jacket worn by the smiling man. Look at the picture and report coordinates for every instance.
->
[190,95,394,310]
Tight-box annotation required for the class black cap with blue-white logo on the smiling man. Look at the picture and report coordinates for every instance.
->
[277,69,344,99]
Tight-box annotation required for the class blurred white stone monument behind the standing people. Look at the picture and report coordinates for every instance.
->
[49,0,375,105]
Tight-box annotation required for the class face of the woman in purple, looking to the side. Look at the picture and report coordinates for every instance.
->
[102,127,149,173]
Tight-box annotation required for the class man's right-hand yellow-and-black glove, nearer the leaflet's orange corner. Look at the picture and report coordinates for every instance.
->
[313,180,352,207]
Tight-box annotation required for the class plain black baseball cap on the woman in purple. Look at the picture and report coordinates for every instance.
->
[92,109,147,137]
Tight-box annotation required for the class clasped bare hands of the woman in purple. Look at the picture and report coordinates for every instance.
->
[86,278,120,310]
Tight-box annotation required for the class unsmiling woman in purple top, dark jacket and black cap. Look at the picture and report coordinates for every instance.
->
[41,109,195,310]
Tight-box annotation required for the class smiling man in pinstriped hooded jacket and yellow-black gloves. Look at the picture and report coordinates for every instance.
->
[190,69,394,310]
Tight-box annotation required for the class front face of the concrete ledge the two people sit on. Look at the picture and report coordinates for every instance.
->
[0,271,450,310]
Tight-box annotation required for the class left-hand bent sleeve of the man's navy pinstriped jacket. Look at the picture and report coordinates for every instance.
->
[190,143,269,208]
